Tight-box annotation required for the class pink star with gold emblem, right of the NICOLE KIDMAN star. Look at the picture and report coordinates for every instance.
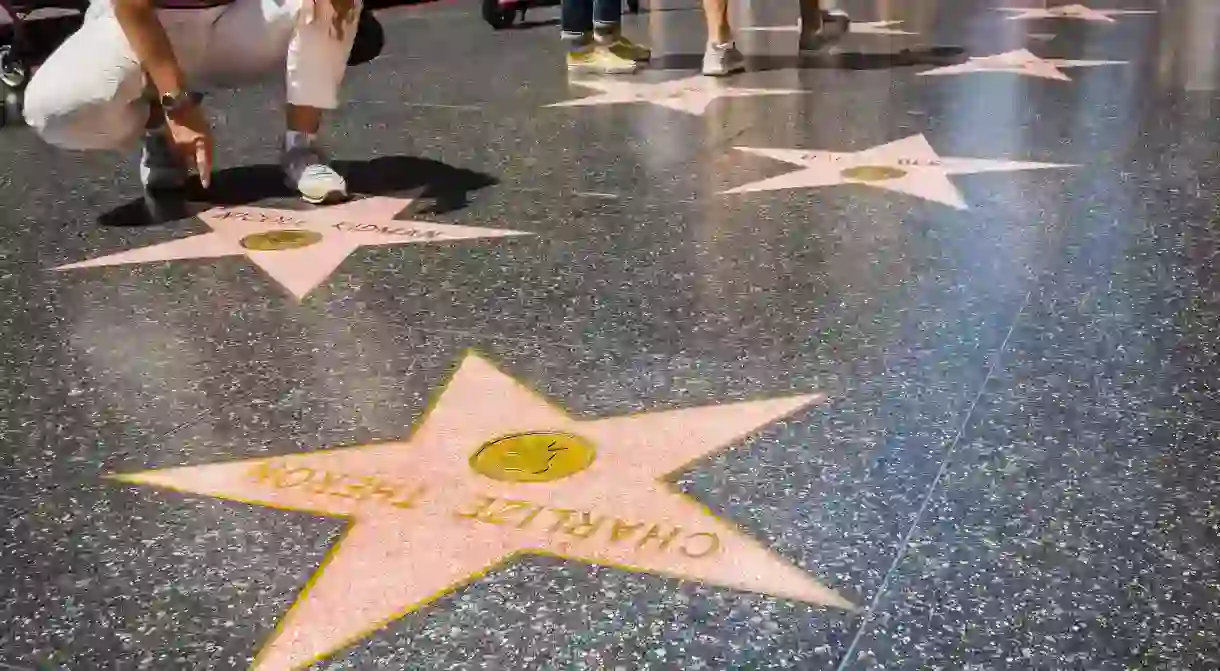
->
[725,134,1072,210]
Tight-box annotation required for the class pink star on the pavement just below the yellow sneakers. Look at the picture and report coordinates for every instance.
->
[548,76,805,115]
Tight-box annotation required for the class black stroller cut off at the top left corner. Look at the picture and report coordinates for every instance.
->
[0,0,89,127]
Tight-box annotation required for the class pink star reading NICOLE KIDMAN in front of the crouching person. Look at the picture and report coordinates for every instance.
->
[55,196,532,300]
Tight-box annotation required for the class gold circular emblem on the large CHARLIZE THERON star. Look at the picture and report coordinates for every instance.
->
[470,431,597,482]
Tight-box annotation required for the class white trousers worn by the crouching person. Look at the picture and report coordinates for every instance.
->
[24,0,360,150]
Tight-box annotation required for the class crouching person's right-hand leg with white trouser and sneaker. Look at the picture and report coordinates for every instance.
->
[206,0,361,203]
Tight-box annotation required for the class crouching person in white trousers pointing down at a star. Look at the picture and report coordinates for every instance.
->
[24,0,361,203]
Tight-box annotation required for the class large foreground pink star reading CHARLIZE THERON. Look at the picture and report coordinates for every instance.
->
[113,354,854,671]
